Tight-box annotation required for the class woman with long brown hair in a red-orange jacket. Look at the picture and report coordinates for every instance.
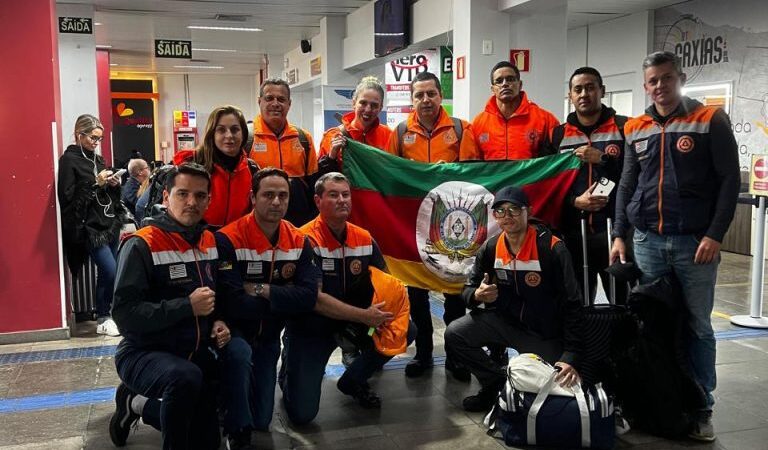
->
[173,106,258,229]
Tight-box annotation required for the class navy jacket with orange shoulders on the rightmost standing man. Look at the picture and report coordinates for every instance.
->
[613,97,740,242]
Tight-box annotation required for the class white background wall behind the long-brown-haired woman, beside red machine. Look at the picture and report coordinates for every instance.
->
[157,74,259,158]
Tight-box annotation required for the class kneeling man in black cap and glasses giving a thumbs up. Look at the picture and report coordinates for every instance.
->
[445,186,581,411]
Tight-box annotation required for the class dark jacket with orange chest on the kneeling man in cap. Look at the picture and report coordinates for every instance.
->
[462,225,581,364]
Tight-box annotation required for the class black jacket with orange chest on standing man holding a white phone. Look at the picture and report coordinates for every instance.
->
[549,105,627,233]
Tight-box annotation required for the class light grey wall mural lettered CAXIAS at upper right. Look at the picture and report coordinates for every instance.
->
[654,0,768,171]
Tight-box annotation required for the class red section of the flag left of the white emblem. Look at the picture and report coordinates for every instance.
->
[350,188,422,262]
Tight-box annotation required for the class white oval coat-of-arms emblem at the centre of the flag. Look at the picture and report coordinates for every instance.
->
[416,181,499,282]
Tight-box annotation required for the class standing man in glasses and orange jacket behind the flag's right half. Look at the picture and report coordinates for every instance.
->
[472,61,560,161]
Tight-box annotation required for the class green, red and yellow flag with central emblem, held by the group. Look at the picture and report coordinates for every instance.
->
[344,140,580,293]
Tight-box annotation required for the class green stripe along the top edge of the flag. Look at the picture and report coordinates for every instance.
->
[344,140,581,198]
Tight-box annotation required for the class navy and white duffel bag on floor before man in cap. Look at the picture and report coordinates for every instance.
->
[484,353,615,449]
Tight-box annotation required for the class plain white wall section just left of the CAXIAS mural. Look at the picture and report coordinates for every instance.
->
[568,11,653,116]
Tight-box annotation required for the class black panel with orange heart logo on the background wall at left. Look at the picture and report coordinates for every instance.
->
[112,98,155,167]
